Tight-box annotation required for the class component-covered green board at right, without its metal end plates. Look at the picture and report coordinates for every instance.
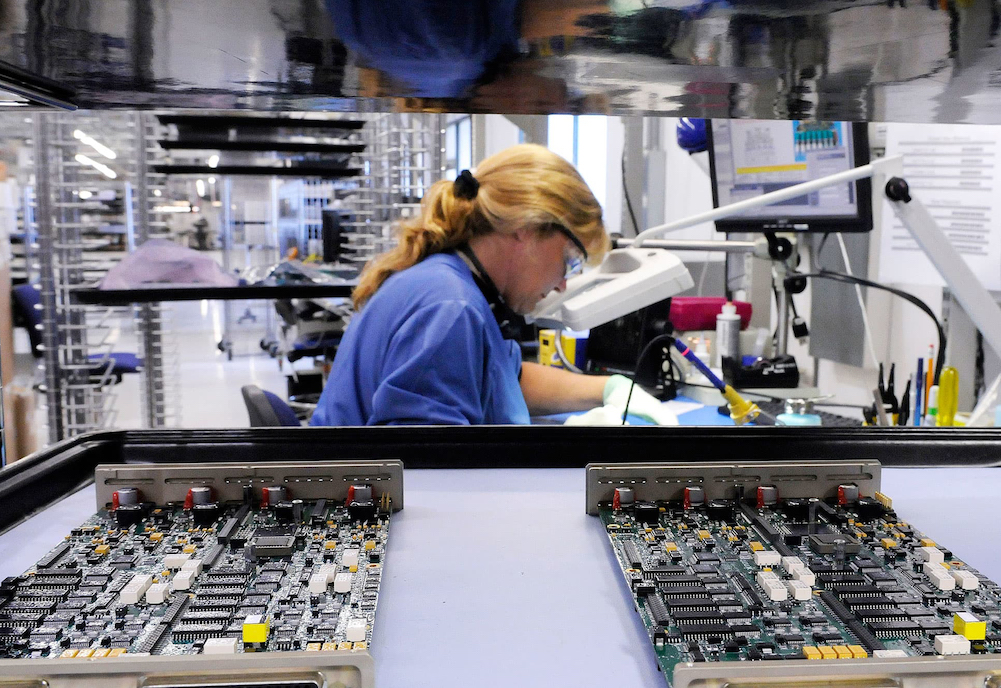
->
[593,465,1001,682]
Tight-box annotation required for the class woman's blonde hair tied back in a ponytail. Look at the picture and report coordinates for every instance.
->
[351,143,609,309]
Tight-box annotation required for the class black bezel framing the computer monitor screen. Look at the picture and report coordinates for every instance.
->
[706,119,873,234]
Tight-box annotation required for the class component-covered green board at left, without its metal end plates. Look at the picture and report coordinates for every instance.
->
[0,485,391,659]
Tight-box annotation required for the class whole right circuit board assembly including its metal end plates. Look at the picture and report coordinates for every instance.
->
[587,460,1001,688]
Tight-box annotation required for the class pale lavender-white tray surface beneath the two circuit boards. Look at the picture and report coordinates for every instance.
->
[0,469,1001,688]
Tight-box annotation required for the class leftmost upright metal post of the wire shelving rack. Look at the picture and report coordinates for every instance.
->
[34,112,64,443]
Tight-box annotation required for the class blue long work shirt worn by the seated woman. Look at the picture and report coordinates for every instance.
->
[309,253,530,426]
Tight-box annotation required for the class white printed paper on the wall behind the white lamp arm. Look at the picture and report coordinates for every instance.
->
[874,124,1001,290]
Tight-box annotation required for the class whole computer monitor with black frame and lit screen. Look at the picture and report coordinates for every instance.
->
[708,119,873,232]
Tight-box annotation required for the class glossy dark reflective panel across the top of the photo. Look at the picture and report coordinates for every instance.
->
[0,0,1001,123]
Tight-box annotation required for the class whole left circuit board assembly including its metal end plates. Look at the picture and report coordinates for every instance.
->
[0,461,403,688]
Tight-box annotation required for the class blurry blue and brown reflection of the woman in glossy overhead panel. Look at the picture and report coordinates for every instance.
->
[325,0,608,103]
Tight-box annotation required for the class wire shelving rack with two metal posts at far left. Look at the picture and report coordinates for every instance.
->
[25,112,177,442]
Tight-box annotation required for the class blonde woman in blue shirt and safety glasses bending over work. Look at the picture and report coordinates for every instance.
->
[311,144,609,426]
